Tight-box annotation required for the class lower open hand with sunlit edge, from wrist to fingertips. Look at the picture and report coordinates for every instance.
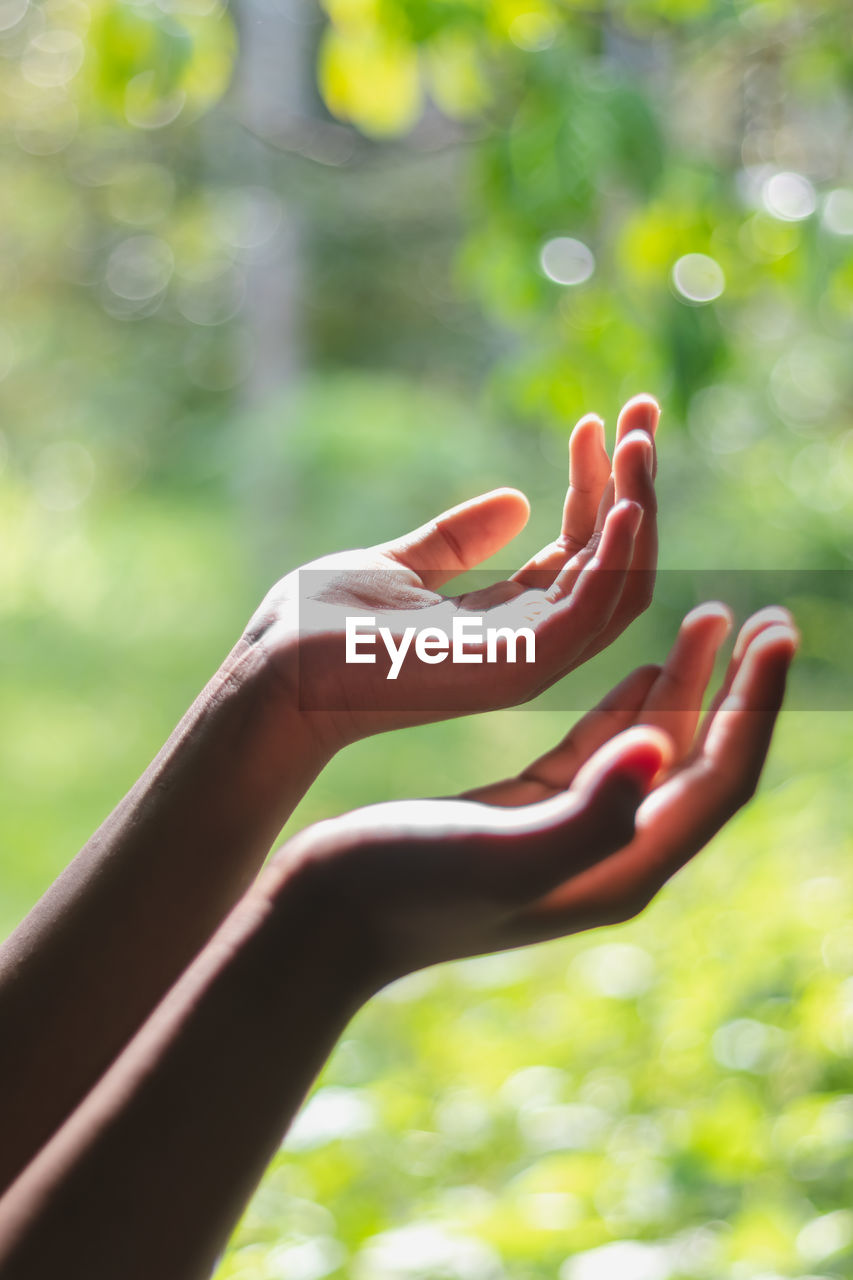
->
[273,604,797,989]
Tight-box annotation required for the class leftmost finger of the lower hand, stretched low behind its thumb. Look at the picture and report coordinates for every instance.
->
[464,666,661,808]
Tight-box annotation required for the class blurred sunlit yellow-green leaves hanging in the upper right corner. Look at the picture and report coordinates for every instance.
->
[320,0,850,445]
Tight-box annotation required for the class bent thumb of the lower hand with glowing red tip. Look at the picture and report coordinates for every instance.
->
[491,727,671,905]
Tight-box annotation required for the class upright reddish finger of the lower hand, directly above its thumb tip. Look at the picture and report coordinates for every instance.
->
[639,602,731,762]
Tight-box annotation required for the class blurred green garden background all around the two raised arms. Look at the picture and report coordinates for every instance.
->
[0,0,853,1280]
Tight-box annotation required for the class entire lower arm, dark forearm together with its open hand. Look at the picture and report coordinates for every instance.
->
[0,608,795,1280]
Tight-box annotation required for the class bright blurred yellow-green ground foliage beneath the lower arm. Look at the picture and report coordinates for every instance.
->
[219,713,853,1280]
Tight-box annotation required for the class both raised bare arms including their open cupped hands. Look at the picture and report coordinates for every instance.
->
[0,397,795,1280]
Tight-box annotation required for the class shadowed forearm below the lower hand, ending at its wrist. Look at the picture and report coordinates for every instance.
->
[0,855,365,1280]
